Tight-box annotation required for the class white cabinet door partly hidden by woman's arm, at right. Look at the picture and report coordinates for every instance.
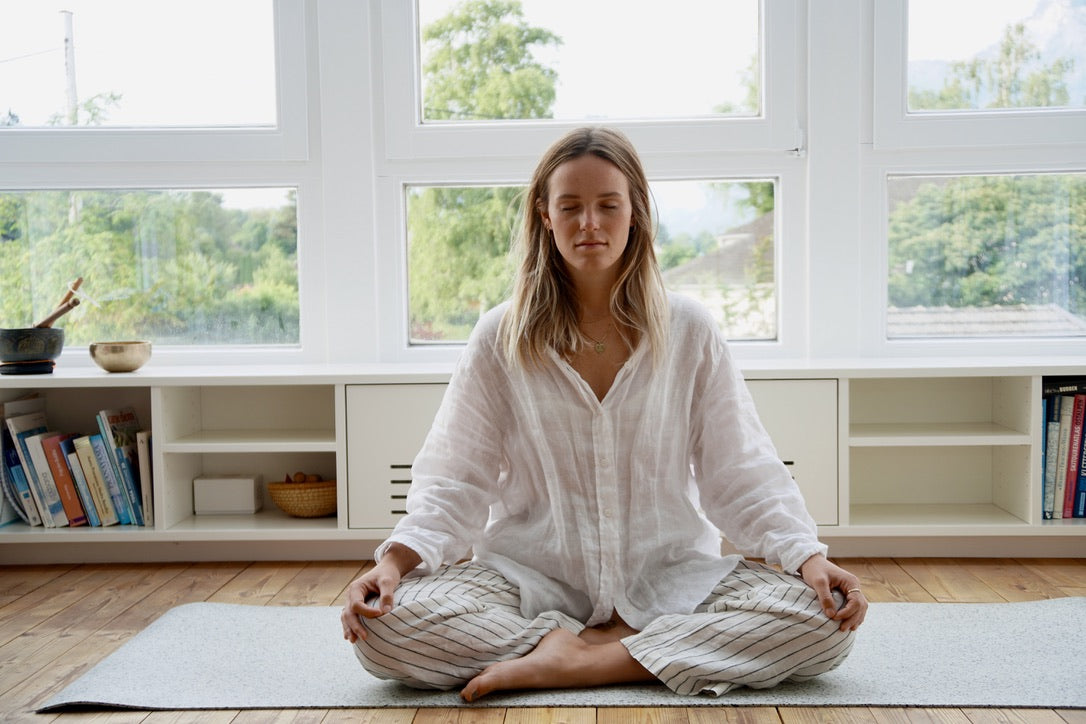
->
[747,380,837,525]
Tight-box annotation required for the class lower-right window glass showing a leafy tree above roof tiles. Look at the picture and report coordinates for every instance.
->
[887,174,1086,338]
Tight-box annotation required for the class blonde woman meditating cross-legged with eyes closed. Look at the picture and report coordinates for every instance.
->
[342,128,867,701]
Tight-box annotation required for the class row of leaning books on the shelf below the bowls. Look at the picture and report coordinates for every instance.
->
[0,396,154,528]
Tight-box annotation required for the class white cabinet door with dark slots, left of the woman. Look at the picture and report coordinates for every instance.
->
[346,384,446,529]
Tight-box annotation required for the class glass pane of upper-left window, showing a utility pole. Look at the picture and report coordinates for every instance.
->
[0,0,276,127]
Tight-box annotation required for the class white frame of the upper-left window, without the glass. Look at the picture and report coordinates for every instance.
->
[0,0,308,163]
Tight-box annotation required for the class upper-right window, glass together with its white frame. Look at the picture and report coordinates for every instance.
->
[874,0,1086,149]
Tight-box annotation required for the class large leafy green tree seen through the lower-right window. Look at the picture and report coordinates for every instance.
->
[888,174,1086,317]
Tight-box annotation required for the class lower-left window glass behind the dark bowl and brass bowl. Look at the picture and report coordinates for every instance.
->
[0,189,300,345]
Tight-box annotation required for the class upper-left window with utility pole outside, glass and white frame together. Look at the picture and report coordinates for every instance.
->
[0,0,307,163]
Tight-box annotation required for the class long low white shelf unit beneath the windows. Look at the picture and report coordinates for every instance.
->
[0,360,1086,563]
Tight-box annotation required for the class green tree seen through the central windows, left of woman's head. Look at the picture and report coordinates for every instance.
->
[407,0,560,340]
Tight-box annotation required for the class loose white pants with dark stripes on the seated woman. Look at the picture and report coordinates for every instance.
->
[355,561,855,695]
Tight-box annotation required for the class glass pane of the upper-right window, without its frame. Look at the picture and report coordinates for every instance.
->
[908,0,1086,112]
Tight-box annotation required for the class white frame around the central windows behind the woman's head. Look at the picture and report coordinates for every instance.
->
[371,0,808,364]
